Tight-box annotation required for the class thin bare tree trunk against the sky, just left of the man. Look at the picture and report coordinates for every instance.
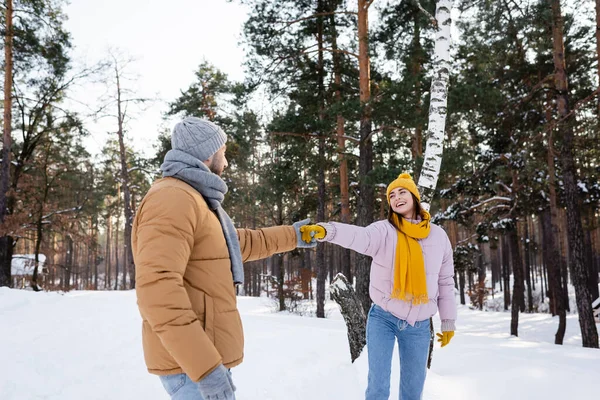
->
[115,65,135,289]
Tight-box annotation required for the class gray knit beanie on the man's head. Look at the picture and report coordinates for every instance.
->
[171,117,227,161]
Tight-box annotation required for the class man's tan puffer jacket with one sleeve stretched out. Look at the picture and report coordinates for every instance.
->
[132,178,297,381]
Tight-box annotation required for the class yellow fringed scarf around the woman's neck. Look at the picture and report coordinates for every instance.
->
[392,210,431,305]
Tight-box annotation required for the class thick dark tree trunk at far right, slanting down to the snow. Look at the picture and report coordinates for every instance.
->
[551,0,599,348]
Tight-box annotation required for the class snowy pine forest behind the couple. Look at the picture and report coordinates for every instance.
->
[0,0,600,348]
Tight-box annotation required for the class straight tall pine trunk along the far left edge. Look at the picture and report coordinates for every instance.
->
[0,0,14,286]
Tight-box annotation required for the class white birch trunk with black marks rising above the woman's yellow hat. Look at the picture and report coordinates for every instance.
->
[418,0,454,211]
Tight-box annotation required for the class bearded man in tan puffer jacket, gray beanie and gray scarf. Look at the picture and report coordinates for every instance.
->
[132,118,316,400]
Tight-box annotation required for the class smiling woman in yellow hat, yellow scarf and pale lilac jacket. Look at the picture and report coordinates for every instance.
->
[301,173,456,400]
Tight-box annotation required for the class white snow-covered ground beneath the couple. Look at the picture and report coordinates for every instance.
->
[0,288,600,400]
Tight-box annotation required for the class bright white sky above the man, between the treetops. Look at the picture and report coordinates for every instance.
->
[64,0,251,156]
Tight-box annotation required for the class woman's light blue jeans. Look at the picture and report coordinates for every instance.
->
[366,304,430,400]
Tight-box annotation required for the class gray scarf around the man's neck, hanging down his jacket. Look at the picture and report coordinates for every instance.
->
[160,150,244,284]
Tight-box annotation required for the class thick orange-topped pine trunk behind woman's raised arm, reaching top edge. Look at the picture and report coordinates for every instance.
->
[356,0,375,315]
